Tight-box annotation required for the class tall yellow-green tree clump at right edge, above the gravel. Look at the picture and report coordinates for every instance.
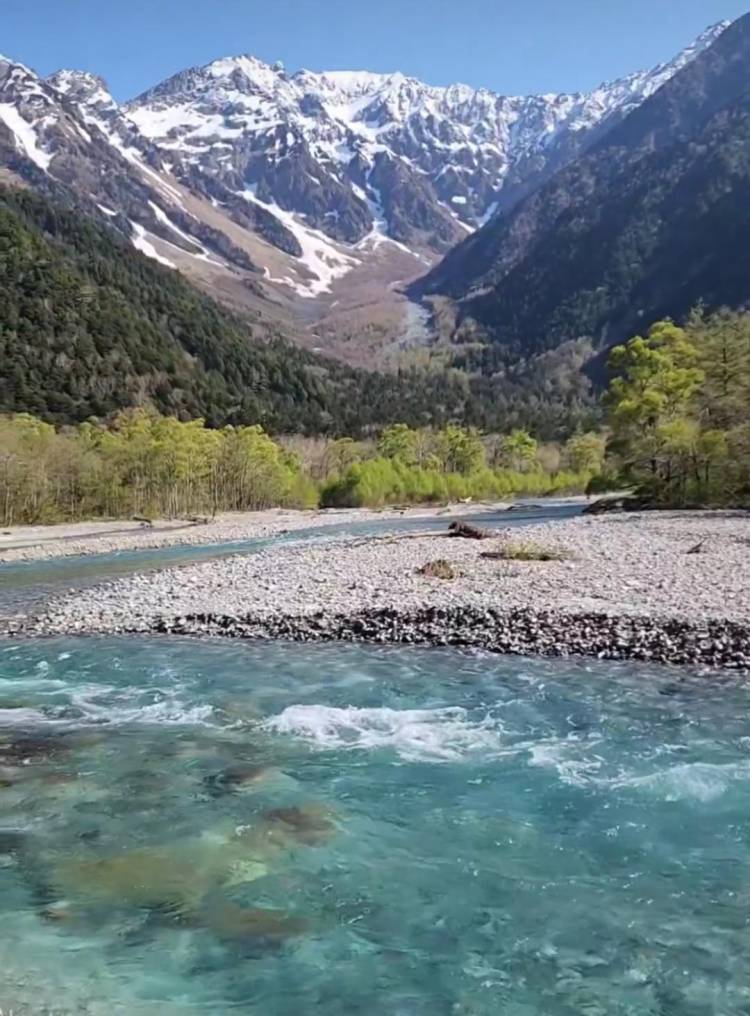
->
[607,311,750,504]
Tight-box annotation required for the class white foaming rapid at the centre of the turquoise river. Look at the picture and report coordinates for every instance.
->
[262,705,502,762]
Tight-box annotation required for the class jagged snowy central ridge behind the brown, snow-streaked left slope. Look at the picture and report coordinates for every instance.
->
[126,24,726,250]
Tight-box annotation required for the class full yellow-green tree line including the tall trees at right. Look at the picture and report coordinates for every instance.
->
[0,310,750,525]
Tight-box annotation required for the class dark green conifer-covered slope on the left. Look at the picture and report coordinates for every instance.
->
[0,188,481,434]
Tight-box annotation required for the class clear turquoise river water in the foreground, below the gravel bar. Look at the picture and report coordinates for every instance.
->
[0,639,750,1016]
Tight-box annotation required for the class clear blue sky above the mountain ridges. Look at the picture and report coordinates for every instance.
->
[0,0,750,99]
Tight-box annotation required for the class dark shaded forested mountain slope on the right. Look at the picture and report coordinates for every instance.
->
[416,16,750,362]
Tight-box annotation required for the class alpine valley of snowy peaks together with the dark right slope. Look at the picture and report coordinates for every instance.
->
[0,16,750,424]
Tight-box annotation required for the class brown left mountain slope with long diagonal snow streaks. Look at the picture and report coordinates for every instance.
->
[0,58,325,335]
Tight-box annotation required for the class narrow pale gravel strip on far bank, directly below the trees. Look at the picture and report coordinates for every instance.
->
[0,498,514,564]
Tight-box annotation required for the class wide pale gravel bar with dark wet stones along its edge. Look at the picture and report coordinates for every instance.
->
[14,512,750,670]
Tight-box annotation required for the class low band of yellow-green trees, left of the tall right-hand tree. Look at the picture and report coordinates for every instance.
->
[0,409,604,526]
